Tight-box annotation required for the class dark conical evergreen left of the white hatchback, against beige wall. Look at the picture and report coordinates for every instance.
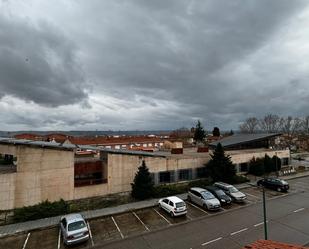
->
[131,161,154,200]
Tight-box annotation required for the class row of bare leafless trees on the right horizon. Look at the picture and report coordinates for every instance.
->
[239,114,309,135]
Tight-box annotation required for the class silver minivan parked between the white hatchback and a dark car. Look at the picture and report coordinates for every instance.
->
[188,188,221,210]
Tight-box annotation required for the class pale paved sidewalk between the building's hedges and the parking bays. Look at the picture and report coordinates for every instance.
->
[0,172,309,238]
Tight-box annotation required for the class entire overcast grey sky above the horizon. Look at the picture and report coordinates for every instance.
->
[0,0,309,131]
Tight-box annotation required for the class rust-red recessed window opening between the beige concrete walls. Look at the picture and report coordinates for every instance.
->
[74,161,107,187]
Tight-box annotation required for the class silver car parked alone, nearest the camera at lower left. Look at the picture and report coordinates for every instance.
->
[60,214,89,245]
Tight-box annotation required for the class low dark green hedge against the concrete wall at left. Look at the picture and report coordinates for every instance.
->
[13,199,69,222]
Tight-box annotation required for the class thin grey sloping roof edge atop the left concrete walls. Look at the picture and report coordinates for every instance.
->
[0,137,166,157]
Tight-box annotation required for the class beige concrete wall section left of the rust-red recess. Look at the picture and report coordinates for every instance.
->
[0,145,74,210]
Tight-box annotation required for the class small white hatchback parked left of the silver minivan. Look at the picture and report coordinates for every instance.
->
[159,196,187,217]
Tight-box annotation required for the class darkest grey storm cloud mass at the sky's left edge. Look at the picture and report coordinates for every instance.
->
[0,14,87,106]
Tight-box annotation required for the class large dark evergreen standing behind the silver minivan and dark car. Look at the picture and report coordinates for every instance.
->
[206,143,236,183]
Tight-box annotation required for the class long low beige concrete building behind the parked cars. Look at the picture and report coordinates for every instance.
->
[0,133,289,210]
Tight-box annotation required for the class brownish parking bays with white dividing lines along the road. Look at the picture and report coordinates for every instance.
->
[0,181,309,249]
